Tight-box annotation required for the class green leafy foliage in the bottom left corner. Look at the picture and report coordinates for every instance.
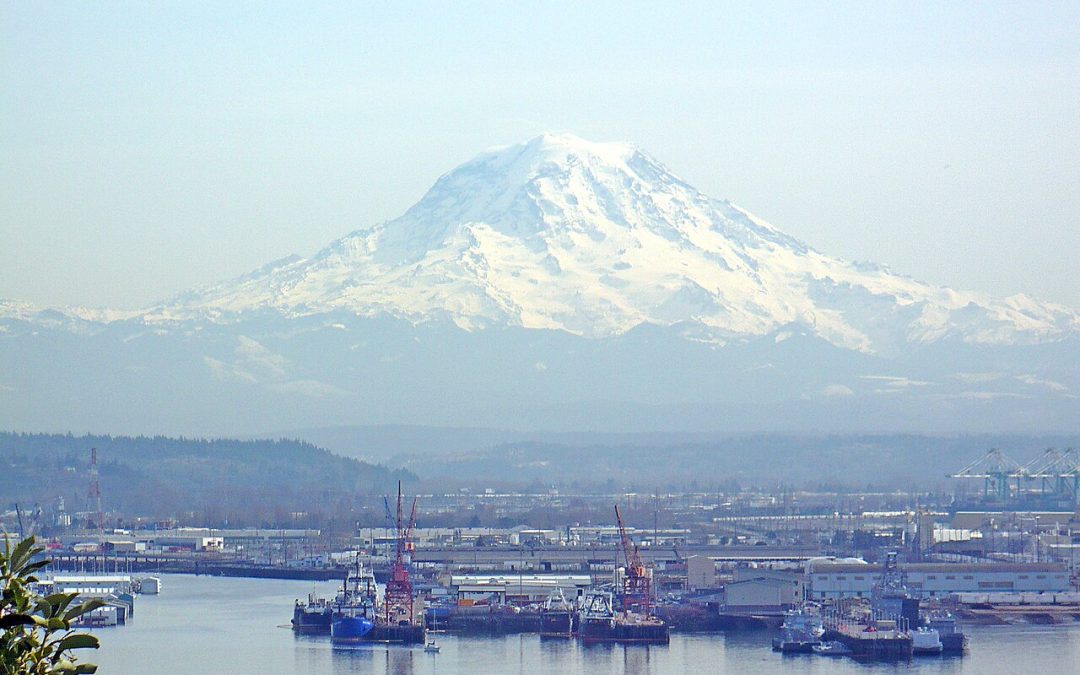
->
[0,535,103,675]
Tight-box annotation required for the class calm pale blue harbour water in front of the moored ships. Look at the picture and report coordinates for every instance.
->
[90,576,1080,675]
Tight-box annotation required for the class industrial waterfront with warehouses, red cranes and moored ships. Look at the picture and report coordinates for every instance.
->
[5,450,1080,672]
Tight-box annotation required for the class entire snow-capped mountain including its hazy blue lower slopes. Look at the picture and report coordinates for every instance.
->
[0,134,1080,434]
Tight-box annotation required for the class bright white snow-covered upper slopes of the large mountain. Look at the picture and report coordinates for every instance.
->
[101,134,1080,352]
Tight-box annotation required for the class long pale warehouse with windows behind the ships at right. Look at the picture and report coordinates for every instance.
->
[807,563,1069,599]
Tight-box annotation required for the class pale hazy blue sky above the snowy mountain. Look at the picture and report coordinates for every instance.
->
[0,1,1080,308]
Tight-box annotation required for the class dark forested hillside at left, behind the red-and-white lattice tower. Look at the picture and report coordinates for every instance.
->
[0,432,414,527]
